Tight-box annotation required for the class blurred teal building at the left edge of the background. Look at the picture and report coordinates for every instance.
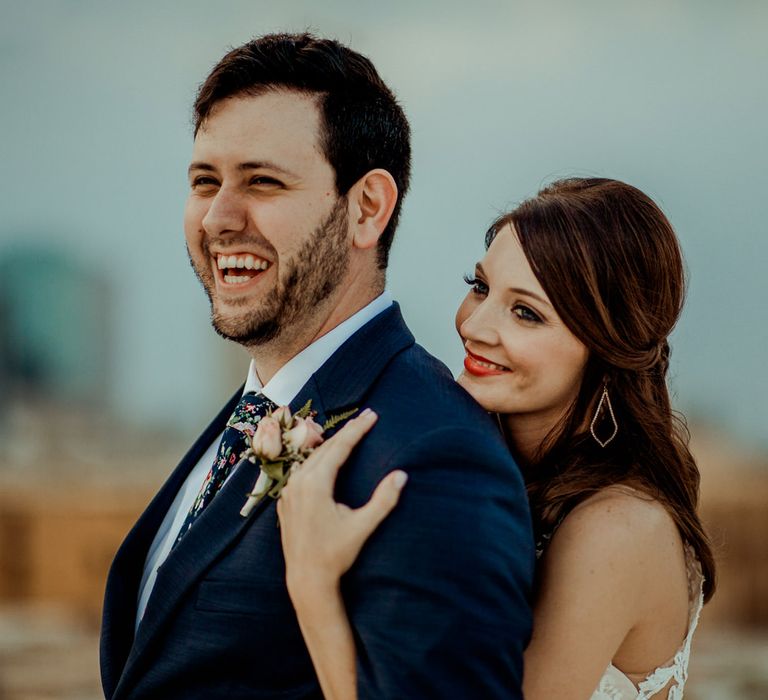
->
[0,246,114,465]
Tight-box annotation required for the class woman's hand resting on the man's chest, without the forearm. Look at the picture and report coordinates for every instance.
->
[277,409,407,609]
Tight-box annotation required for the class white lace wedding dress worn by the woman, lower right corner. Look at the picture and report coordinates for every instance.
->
[590,546,704,700]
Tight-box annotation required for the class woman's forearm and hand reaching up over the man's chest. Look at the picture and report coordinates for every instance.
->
[277,411,407,700]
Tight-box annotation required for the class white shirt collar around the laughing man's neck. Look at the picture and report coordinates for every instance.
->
[243,291,392,406]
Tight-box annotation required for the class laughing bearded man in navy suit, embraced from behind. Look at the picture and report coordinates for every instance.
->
[101,34,533,700]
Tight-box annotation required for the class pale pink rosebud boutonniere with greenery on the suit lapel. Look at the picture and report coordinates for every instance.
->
[240,399,357,518]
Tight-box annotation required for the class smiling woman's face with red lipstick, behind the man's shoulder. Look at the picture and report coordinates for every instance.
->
[456,226,588,433]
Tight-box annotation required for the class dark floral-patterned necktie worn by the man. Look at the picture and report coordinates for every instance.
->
[173,392,277,547]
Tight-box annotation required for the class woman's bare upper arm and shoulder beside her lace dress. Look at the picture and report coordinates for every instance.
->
[523,489,687,700]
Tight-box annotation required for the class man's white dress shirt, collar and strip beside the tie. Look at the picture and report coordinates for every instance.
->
[136,291,392,629]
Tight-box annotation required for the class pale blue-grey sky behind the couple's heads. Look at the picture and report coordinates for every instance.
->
[0,0,768,445]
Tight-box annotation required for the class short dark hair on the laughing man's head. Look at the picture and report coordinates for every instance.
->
[194,33,411,269]
